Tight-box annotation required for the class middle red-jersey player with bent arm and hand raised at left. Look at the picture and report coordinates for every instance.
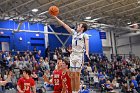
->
[43,58,62,93]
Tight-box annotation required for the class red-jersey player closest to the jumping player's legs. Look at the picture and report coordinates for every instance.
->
[62,59,72,93]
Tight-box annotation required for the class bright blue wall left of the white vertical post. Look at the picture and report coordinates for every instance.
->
[0,20,45,54]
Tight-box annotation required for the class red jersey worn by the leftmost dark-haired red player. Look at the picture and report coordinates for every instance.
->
[17,77,35,93]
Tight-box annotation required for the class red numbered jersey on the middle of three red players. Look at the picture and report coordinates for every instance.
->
[52,70,62,93]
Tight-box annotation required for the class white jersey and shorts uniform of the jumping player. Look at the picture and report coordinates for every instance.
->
[70,30,89,68]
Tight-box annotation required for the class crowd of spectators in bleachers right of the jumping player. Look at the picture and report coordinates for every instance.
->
[82,55,140,93]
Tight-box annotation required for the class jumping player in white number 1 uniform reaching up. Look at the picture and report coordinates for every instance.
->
[54,16,89,91]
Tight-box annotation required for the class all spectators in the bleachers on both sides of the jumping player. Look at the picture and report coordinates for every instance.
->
[0,46,140,93]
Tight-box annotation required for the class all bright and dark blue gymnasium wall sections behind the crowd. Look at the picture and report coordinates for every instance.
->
[0,20,103,54]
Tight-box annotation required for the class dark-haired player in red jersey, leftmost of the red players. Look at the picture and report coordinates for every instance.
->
[17,68,36,93]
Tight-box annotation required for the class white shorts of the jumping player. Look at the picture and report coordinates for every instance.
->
[70,52,84,68]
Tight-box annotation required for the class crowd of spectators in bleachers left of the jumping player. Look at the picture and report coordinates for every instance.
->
[0,46,70,93]
